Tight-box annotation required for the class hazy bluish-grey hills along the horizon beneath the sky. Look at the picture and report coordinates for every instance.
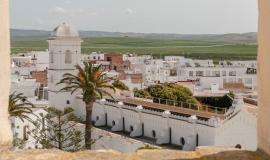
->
[11,29,257,43]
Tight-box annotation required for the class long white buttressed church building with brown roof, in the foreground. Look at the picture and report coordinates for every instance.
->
[92,96,257,150]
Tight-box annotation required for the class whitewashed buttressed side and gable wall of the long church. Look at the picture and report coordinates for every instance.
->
[92,102,256,150]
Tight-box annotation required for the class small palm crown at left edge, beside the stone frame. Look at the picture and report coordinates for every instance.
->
[8,92,34,121]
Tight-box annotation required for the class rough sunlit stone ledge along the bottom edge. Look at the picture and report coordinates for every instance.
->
[0,147,270,160]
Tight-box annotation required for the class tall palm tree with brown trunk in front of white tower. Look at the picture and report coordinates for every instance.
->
[57,62,115,149]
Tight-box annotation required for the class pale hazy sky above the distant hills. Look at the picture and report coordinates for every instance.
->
[10,0,258,34]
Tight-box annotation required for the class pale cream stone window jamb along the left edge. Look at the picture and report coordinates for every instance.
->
[0,0,12,149]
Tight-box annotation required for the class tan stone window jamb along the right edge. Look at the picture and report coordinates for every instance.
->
[258,0,270,154]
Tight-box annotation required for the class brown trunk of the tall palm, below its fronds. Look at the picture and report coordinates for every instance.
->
[85,101,94,149]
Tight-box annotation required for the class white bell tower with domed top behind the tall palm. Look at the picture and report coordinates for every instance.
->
[47,23,82,109]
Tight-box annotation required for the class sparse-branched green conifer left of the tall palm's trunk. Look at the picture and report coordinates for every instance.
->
[28,107,83,151]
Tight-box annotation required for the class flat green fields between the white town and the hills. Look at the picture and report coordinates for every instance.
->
[11,37,257,60]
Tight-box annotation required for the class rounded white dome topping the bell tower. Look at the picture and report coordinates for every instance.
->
[50,23,80,39]
